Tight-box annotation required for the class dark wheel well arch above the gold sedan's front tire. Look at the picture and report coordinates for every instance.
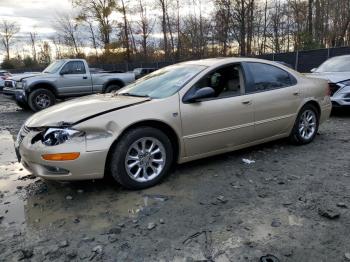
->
[105,120,180,176]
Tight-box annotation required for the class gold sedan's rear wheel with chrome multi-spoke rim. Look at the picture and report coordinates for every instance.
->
[289,104,319,145]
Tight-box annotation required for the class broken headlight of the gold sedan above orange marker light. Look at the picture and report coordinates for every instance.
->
[41,128,84,146]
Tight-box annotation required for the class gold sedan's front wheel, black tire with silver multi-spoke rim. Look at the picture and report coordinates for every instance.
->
[109,127,174,189]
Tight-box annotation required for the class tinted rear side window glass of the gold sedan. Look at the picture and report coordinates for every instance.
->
[247,63,296,92]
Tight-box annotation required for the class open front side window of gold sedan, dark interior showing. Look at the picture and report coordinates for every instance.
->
[193,64,244,97]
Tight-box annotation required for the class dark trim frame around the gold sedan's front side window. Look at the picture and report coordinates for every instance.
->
[181,62,247,104]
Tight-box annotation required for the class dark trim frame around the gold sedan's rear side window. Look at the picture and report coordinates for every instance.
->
[242,61,298,95]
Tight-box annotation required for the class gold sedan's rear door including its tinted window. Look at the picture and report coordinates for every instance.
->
[244,62,302,141]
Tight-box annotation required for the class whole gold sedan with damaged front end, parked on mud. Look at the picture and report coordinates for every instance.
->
[16,58,331,189]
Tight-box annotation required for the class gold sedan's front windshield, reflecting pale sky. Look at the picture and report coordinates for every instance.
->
[118,64,206,98]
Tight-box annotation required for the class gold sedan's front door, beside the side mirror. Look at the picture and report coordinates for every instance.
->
[180,64,254,157]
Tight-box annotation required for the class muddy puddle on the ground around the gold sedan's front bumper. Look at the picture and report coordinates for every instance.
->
[0,131,191,232]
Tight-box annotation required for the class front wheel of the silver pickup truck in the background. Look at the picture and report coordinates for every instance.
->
[28,88,56,112]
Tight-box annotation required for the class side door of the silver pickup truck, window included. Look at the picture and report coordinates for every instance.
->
[57,61,92,95]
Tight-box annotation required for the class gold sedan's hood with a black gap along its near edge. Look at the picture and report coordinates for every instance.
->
[25,94,150,127]
